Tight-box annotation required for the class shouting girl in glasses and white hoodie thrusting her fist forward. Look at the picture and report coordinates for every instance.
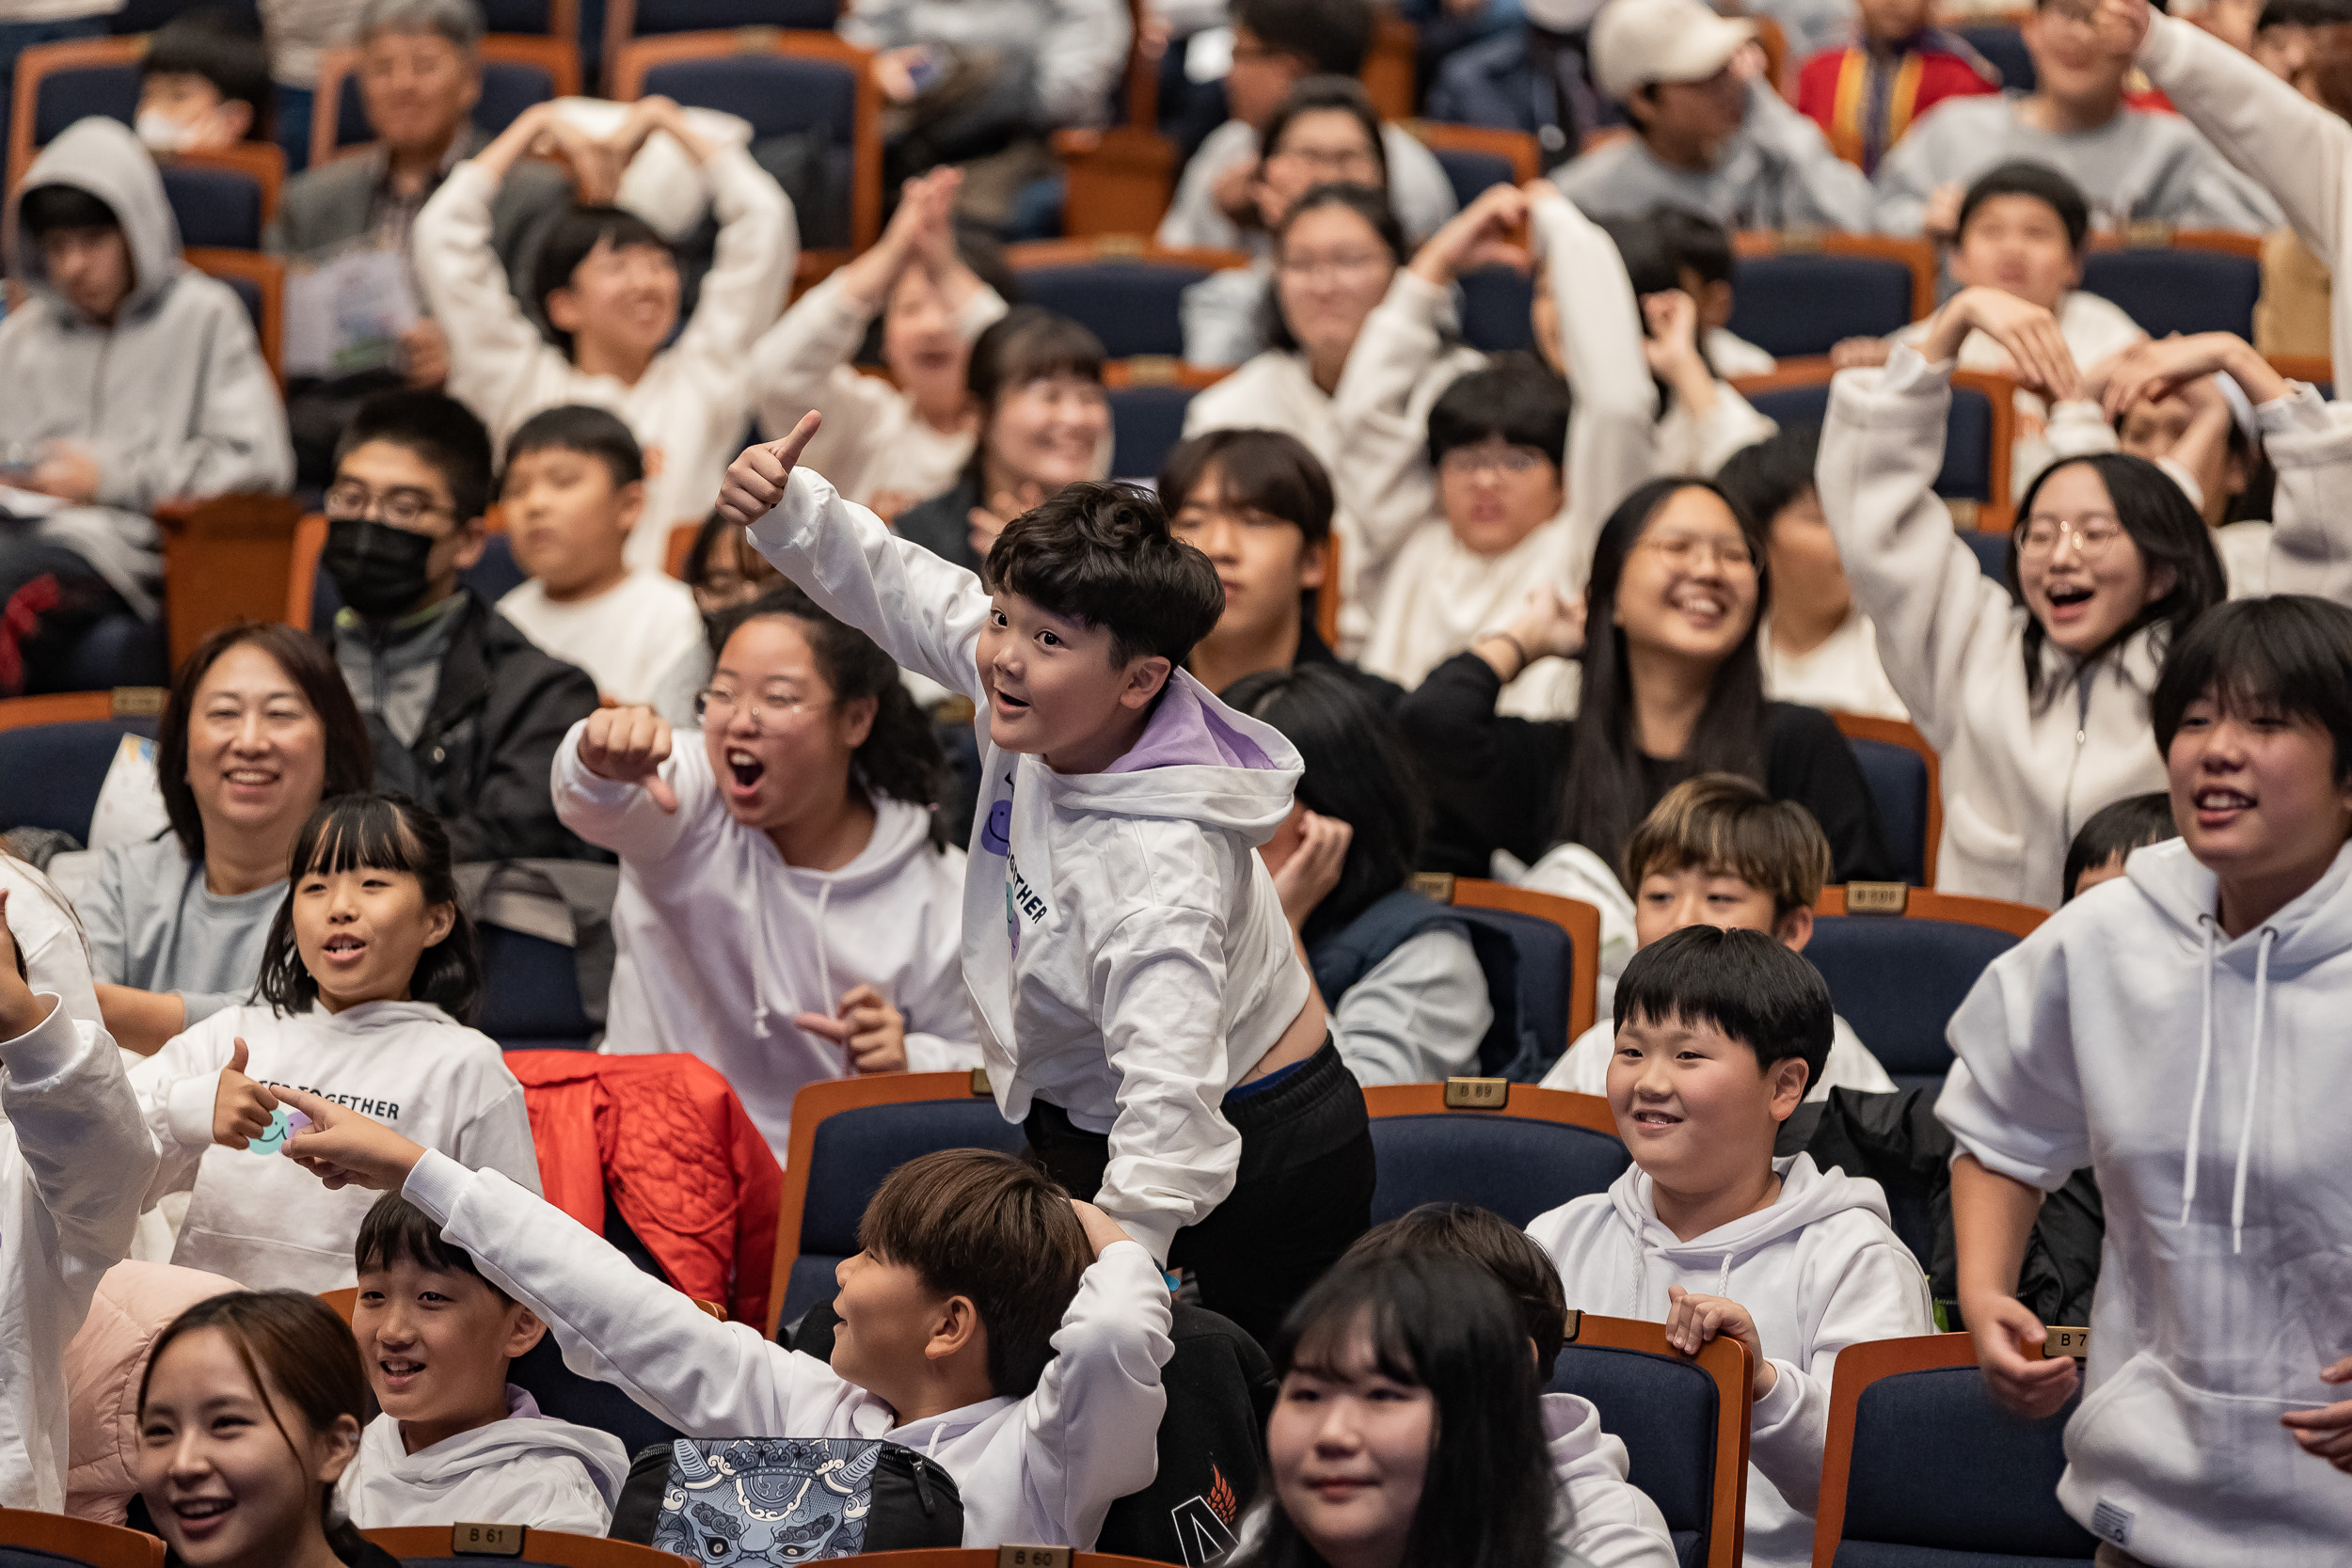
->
[555,583,981,1162]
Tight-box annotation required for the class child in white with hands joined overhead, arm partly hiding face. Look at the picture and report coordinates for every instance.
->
[751,166,1011,519]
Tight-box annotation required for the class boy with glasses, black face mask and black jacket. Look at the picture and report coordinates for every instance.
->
[320,392,600,861]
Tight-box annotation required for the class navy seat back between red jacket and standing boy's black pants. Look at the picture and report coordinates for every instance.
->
[767,1072,1028,1338]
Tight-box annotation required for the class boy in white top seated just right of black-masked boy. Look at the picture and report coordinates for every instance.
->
[499,402,704,703]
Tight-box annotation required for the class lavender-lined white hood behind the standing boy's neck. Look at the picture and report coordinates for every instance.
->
[1047,670,1306,844]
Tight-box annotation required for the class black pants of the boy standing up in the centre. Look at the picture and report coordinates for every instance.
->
[1024,1039,1374,1345]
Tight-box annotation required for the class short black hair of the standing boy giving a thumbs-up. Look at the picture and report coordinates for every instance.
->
[986,482,1226,665]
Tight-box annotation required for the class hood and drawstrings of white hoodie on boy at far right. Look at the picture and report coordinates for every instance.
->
[2124,839,2352,1253]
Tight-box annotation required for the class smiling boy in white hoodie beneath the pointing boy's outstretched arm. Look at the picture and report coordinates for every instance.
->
[339,1192,628,1535]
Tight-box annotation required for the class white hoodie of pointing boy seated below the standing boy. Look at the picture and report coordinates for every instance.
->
[403,1154,1174,1552]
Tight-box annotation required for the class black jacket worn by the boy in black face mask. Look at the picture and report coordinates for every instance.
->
[331,588,605,861]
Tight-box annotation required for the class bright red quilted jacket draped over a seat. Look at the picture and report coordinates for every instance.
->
[506,1051,784,1328]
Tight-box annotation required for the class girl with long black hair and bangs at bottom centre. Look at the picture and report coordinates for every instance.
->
[1228,1256,1583,1568]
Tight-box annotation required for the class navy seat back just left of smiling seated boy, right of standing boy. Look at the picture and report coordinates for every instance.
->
[1364,1079,1632,1225]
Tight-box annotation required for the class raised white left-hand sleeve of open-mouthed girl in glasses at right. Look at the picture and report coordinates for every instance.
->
[1814,345,2016,750]
